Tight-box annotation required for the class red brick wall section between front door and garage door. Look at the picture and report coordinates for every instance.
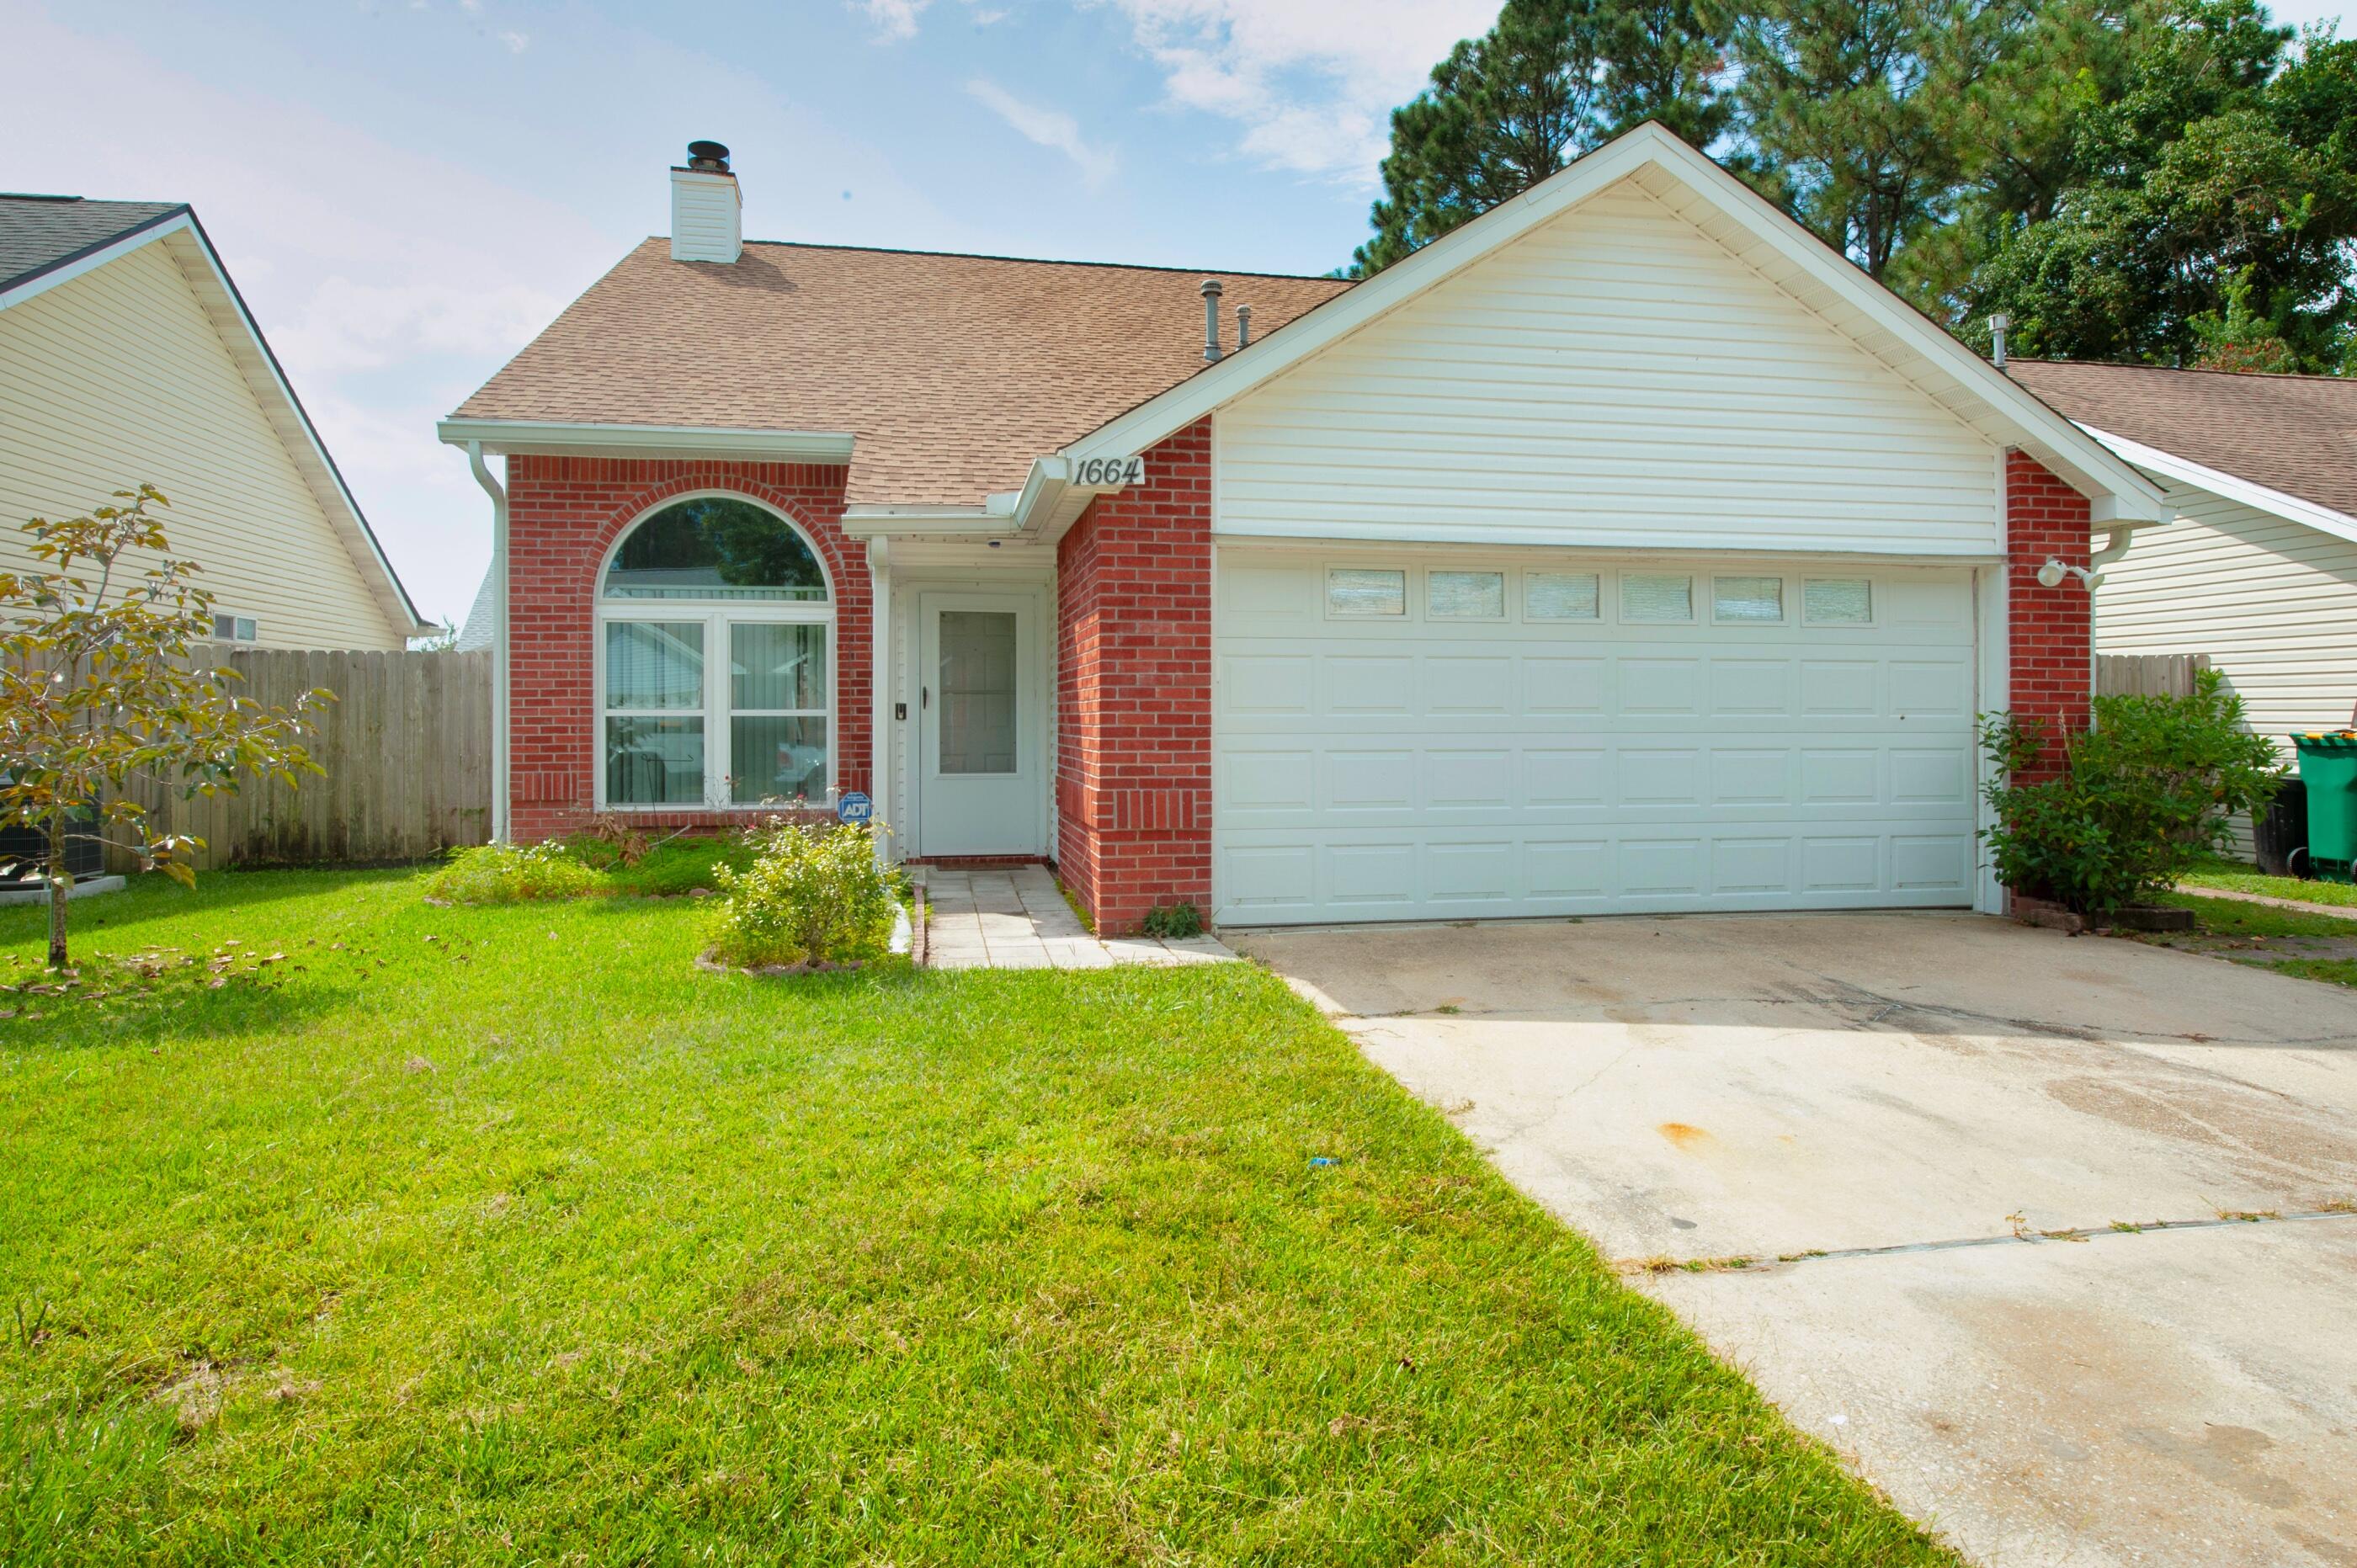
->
[1056,420,1211,933]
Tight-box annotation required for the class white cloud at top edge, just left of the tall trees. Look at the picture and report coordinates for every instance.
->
[1084,0,1497,182]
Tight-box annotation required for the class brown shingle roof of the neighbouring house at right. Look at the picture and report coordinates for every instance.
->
[2006,359,2357,517]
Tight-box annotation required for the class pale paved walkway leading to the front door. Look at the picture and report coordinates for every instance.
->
[910,865,1235,969]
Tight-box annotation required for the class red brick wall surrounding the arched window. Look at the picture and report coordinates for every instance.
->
[507,457,872,844]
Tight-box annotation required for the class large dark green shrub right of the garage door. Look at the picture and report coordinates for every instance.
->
[1980,670,2281,915]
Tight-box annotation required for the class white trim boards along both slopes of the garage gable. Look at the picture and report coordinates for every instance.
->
[1061,123,2166,524]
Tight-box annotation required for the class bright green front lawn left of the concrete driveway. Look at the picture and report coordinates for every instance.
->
[0,873,1951,1565]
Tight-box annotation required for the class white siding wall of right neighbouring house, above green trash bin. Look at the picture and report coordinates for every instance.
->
[2095,481,2357,853]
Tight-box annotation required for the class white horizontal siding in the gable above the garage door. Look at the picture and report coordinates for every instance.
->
[1216,184,1998,554]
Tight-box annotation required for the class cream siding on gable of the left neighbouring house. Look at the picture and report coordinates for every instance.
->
[0,243,407,648]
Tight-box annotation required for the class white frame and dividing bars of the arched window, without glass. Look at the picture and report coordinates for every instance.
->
[589,491,843,816]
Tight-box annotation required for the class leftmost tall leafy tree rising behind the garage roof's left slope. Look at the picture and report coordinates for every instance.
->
[1349,0,1730,279]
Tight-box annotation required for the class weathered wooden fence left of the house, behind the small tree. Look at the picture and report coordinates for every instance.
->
[109,646,490,870]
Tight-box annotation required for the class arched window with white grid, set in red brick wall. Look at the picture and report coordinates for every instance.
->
[596,495,834,806]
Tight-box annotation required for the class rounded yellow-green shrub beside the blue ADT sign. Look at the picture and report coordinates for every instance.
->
[712,818,893,969]
